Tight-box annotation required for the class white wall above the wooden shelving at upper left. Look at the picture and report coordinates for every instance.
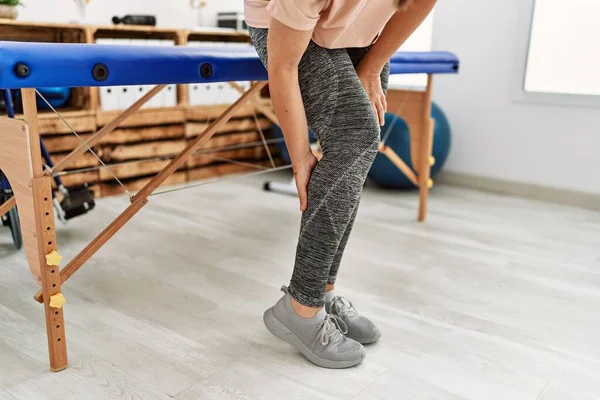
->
[19,0,243,29]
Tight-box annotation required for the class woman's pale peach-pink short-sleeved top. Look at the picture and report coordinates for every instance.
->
[244,0,397,49]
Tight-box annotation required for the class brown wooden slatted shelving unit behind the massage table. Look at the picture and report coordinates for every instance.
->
[0,19,282,196]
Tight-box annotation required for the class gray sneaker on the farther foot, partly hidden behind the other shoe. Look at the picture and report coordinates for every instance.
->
[325,292,381,344]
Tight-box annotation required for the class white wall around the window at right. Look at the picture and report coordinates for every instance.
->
[433,0,600,194]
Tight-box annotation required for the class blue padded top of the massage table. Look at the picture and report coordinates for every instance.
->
[0,41,459,89]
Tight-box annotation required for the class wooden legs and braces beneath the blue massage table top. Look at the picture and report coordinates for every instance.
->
[0,76,433,371]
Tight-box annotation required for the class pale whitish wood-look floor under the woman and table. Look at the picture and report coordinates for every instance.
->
[0,170,600,400]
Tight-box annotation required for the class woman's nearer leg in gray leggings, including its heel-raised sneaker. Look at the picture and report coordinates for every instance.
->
[250,25,380,368]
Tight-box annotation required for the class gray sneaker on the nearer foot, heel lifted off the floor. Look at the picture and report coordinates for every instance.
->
[263,286,366,368]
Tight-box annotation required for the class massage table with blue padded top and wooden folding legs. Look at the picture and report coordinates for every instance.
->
[0,41,459,371]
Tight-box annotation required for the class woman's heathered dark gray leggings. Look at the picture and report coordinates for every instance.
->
[250,28,389,307]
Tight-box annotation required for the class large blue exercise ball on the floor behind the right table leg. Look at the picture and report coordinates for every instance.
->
[369,103,451,189]
